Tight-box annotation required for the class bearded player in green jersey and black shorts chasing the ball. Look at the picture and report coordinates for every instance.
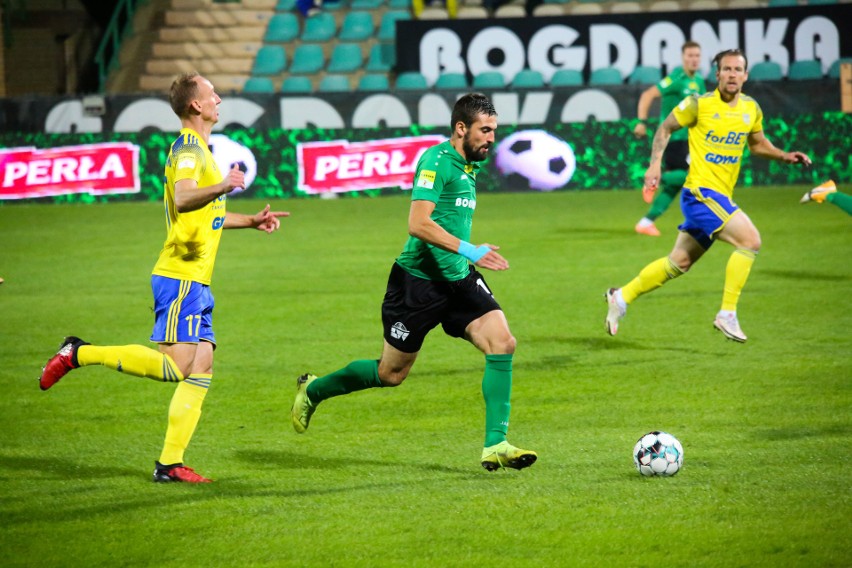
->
[291,93,537,471]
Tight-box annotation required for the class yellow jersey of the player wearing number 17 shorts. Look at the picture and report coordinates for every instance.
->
[153,128,226,285]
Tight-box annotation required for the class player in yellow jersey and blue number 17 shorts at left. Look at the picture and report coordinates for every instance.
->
[39,73,288,483]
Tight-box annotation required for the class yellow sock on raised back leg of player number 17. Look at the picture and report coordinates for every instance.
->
[77,345,183,383]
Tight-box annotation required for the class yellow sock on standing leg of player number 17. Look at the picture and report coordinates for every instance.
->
[160,373,213,465]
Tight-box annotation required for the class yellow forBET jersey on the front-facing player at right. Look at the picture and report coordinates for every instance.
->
[672,89,763,197]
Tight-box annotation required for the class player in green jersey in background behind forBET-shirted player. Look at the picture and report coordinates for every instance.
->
[633,41,707,237]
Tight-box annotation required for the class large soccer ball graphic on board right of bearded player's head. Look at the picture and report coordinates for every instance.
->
[495,130,577,191]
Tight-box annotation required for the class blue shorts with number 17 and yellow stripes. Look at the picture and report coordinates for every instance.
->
[151,275,216,345]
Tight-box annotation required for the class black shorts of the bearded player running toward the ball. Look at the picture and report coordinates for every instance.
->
[382,263,500,353]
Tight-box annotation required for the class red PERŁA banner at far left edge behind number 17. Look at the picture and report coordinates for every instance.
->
[0,142,140,199]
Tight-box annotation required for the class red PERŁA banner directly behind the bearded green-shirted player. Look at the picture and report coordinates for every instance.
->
[296,136,447,194]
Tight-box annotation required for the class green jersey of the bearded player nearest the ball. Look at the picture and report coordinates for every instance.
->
[396,141,479,282]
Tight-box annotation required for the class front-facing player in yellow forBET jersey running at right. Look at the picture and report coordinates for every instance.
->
[605,49,811,343]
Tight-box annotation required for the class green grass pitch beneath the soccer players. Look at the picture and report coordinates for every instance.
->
[0,187,852,567]
